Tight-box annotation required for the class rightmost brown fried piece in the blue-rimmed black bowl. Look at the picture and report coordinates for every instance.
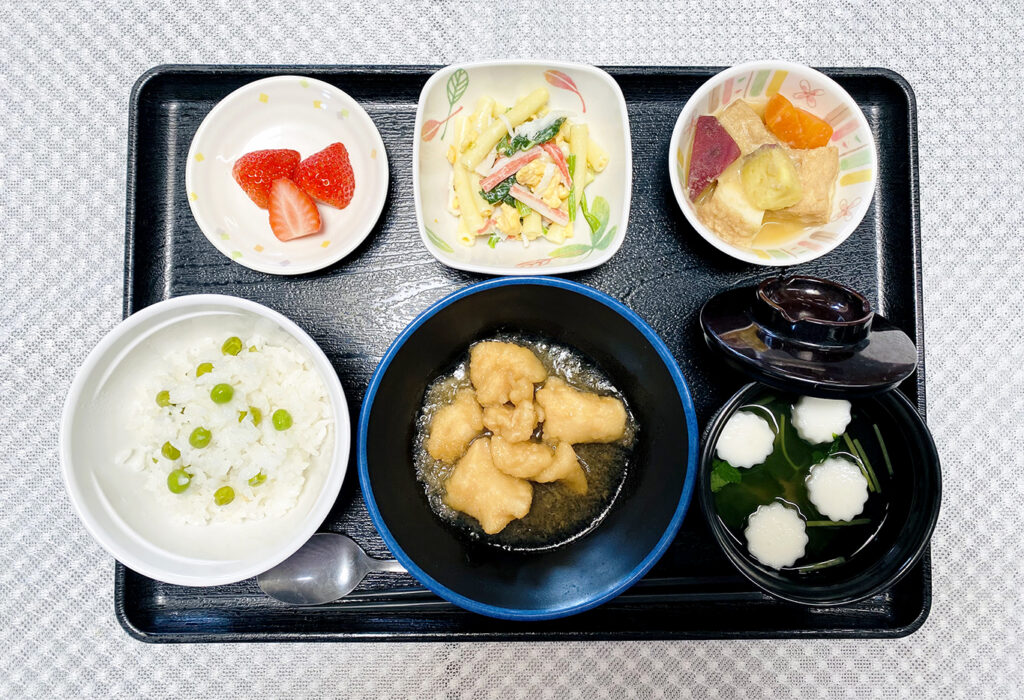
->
[537,377,626,444]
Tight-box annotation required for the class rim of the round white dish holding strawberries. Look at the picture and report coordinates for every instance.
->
[184,73,391,276]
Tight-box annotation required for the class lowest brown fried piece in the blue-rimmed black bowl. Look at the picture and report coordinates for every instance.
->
[444,438,534,534]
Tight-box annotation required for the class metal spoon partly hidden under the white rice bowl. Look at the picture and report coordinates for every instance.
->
[256,532,406,605]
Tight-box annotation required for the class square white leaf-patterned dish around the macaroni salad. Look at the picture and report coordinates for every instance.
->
[413,60,633,274]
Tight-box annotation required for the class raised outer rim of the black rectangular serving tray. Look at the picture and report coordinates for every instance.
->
[114,63,932,644]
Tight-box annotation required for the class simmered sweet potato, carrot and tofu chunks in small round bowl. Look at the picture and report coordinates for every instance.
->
[686,93,839,248]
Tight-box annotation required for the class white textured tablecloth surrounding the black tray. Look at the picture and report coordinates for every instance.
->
[0,0,1024,698]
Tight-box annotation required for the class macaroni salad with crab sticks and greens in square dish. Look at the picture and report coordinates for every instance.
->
[447,87,608,248]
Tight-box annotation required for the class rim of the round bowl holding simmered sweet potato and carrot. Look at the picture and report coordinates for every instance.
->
[669,59,879,267]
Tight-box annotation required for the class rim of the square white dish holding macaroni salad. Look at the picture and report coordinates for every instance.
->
[413,58,633,275]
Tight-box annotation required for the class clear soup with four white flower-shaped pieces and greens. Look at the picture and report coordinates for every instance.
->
[711,396,893,573]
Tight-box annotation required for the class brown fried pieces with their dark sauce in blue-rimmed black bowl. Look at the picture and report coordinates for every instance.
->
[414,338,636,549]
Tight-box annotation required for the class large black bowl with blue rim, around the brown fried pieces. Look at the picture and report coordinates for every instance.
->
[358,277,698,620]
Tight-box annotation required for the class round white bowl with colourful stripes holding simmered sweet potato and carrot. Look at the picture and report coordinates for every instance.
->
[669,60,878,266]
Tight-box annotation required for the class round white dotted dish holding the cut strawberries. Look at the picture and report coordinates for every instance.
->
[185,76,388,274]
